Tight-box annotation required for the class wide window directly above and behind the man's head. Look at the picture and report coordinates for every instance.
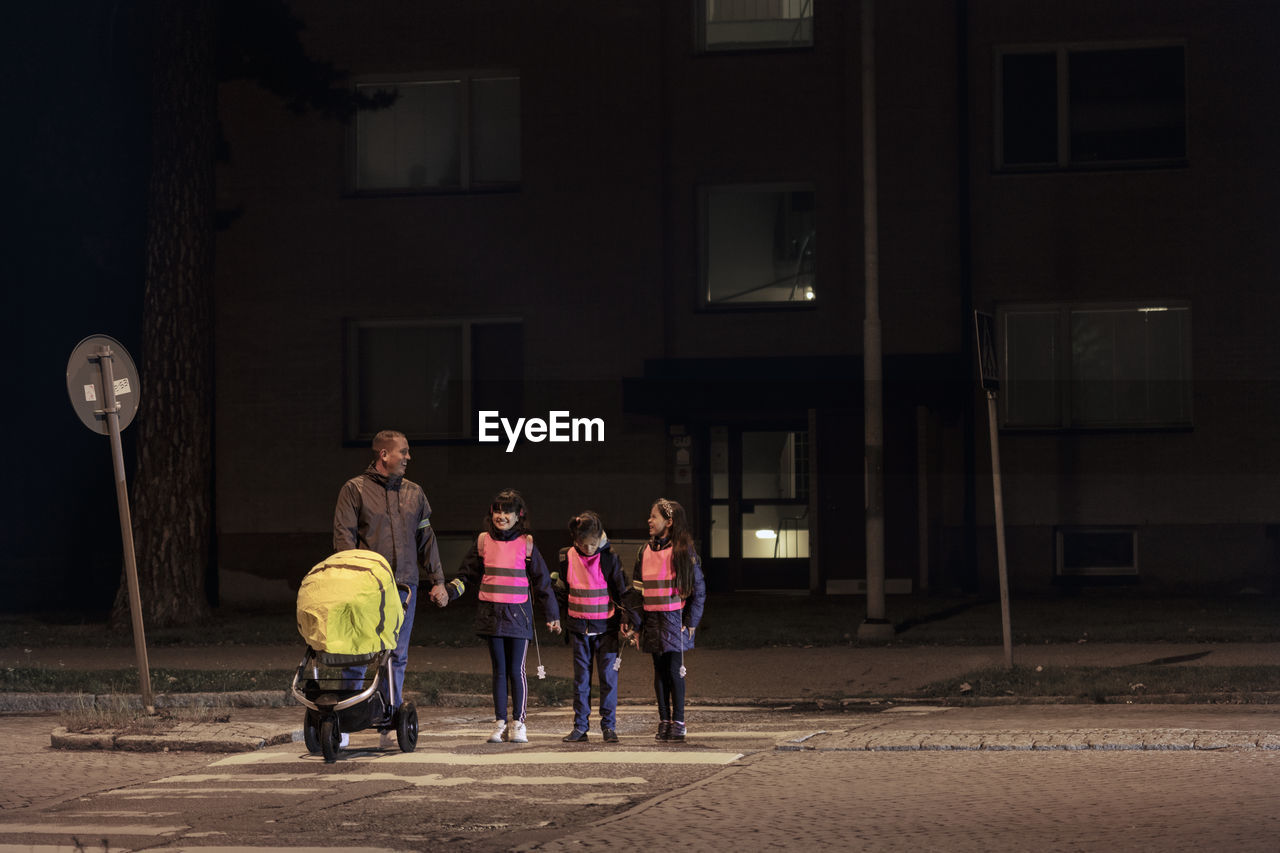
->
[344,318,524,441]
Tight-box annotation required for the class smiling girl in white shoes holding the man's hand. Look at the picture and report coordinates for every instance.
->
[449,489,561,743]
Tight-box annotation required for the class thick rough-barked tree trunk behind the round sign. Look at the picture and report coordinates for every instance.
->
[113,0,218,628]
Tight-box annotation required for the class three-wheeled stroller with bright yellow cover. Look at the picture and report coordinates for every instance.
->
[291,549,417,763]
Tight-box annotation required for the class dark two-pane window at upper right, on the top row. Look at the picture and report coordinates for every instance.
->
[996,45,1187,170]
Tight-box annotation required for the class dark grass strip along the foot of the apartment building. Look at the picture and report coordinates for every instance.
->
[0,589,1280,645]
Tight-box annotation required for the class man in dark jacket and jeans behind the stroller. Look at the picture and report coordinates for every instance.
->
[333,429,449,747]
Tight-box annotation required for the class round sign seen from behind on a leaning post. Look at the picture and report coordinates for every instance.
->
[67,334,155,713]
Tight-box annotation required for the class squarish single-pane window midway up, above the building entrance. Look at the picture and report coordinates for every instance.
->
[700,184,817,306]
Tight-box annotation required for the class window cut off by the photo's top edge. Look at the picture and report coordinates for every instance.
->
[696,0,813,51]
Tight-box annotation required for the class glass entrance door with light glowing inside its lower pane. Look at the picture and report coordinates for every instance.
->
[708,425,809,589]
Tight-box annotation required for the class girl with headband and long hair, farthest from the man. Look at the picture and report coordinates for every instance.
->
[630,498,707,742]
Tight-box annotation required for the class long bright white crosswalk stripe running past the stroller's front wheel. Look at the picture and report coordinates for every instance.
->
[210,749,742,767]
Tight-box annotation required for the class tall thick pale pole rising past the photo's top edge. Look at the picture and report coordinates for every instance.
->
[858,0,893,639]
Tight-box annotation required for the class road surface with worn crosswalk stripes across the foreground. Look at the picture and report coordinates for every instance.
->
[0,706,1280,852]
